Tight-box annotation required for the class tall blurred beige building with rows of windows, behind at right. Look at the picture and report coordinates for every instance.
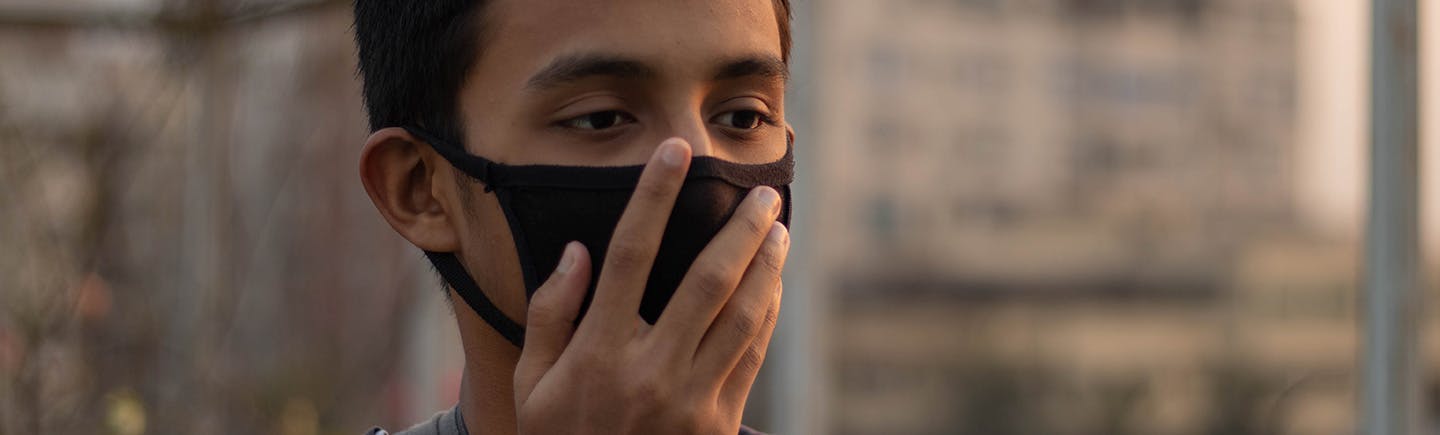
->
[811,0,1296,301]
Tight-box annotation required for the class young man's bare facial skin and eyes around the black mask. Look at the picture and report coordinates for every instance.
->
[445,0,788,320]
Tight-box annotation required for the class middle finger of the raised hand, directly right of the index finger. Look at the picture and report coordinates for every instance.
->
[651,186,783,352]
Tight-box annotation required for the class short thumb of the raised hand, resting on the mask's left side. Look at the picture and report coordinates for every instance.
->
[514,242,590,405]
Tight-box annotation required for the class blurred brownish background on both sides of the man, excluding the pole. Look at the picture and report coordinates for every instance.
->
[0,0,1440,435]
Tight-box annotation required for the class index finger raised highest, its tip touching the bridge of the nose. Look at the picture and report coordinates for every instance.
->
[586,138,690,330]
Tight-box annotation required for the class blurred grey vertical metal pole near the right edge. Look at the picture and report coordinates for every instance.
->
[1361,0,1420,435]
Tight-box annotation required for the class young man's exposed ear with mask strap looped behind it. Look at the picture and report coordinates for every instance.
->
[360,127,459,252]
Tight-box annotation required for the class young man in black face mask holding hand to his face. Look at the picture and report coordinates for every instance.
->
[354,0,793,435]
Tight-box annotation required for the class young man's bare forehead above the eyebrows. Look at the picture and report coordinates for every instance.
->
[480,0,780,75]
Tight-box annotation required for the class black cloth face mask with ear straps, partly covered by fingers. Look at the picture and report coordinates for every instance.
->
[406,127,795,346]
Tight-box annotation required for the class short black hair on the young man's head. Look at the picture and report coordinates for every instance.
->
[354,0,791,145]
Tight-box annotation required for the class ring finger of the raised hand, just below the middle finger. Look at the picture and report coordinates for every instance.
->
[694,225,789,379]
